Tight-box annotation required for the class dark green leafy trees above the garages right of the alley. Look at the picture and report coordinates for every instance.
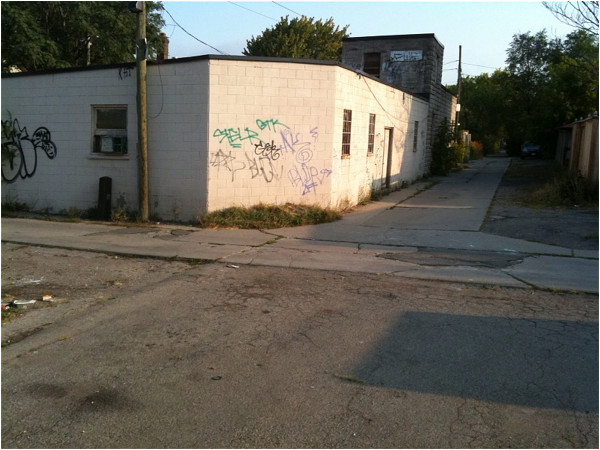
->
[461,30,598,156]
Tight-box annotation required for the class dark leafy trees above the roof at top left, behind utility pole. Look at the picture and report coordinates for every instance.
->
[2,1,164,71]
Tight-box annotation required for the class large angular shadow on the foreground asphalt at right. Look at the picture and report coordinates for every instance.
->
[353,312,598,413]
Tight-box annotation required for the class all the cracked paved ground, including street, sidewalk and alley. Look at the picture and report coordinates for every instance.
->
[1,161,598,448]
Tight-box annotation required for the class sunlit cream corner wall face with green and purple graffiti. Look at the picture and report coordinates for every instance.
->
[208,59,335,211]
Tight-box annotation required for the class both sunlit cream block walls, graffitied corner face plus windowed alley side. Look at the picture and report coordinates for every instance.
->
[208,59,428,211]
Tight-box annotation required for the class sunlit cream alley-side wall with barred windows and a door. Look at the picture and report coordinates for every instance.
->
[332,67,428,206]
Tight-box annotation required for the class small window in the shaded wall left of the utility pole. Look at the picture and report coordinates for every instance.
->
[92,106,127,155]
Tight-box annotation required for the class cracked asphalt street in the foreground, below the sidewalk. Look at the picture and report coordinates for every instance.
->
[2,243,598,448]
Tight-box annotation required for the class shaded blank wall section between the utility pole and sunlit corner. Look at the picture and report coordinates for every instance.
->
[147,59,209,220]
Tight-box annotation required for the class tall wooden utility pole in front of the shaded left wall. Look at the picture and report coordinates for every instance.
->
[129,2,149,222]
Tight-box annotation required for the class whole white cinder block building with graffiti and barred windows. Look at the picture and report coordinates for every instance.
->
[2,33,452,221]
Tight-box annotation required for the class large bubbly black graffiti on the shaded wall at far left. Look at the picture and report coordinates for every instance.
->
[2,118,57,183]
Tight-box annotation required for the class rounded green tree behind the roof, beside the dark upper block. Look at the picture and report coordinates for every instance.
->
[242,16,348,61]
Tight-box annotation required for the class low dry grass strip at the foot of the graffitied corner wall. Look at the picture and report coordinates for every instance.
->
[198,203,342,229]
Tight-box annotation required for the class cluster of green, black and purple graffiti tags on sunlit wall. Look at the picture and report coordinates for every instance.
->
[209,118,332,195]
